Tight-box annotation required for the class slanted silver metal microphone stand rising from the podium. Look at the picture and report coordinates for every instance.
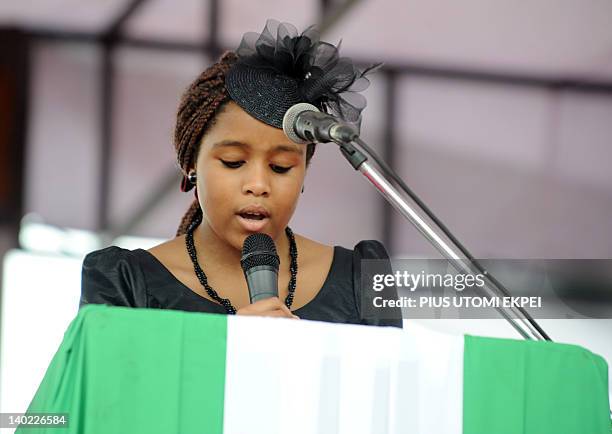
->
[332,135,551,341]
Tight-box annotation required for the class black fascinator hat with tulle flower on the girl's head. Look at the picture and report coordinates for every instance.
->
[225,20,381,128]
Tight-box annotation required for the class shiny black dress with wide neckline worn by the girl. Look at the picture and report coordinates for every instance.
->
[79,240,402,327]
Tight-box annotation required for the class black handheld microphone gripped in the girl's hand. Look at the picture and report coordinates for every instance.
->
[240,233,280,303]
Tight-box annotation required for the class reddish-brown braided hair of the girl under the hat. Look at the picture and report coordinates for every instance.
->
[174,51,316,237]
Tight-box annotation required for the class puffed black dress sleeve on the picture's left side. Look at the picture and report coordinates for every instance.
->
[79,246,148,308]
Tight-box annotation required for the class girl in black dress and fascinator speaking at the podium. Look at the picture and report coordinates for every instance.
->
[80,20,402,327]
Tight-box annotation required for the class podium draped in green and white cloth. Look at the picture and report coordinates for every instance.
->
[17,305,610,434]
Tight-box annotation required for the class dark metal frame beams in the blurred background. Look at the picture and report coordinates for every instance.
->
[19,0,612,251]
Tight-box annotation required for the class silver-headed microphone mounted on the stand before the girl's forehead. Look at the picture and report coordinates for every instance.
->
[283,103,359,143]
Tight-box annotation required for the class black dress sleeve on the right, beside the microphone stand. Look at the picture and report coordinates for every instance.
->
[353,240,403,328]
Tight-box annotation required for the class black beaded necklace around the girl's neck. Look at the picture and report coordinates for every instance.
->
[185,213,298,315]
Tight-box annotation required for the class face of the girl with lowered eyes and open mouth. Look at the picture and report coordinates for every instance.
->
[195,102,306,250]
